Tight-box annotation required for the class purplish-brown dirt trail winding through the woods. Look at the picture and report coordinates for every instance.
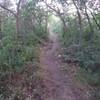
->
[40,29,90,100]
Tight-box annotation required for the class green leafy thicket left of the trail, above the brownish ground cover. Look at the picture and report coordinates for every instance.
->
[0,3,46,72]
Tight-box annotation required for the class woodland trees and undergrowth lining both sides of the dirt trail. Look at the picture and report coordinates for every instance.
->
[0,0,100,100]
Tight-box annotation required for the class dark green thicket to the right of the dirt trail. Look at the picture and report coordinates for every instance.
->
[61,13,100,100]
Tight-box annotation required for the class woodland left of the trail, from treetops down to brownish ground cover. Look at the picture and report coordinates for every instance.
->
[0,0,47,100]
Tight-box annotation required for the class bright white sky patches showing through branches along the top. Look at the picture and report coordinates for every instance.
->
[1,0,100,14]
